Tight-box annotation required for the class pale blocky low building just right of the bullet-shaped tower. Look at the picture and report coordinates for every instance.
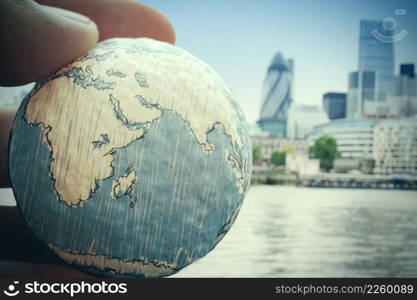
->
[287,103,329,140]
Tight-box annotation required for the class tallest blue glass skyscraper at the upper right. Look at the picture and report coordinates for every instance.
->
[358,19,395,101]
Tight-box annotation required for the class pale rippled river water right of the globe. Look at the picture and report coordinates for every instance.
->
[173,185,417,277]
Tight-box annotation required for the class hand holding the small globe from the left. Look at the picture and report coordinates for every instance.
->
[0,0,175,277]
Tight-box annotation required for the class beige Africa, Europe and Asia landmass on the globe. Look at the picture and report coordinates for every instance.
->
[24,39,247,206]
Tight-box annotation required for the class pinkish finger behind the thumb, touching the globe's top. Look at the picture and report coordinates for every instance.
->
[38,0,175,44]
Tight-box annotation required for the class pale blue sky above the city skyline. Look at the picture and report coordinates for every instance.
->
[141,0,417,123]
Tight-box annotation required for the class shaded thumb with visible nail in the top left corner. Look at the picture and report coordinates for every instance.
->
[0,0,98,86]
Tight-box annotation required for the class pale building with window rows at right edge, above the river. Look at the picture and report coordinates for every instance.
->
[373,117,417,175]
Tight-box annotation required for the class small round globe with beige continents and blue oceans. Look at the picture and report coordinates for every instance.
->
[9,38,252,277]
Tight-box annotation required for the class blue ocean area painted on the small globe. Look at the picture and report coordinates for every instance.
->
[9,38,252,277]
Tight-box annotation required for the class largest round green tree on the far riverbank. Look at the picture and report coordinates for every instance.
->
[308,135,340,172]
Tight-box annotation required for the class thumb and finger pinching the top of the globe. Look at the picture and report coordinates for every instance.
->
[0,0,175,86]
